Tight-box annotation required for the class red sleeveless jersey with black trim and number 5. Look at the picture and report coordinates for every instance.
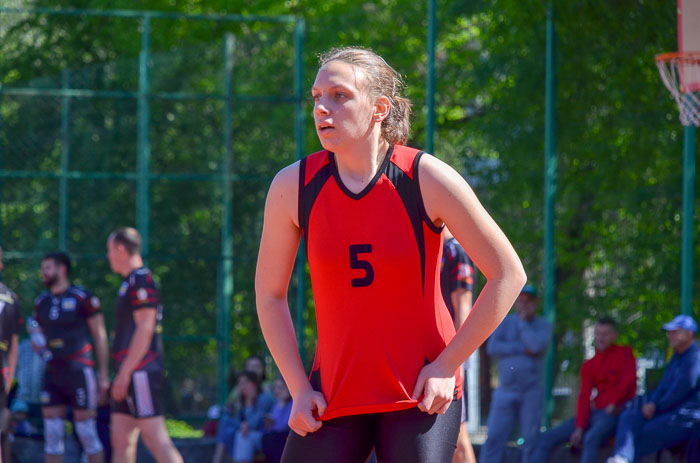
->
[299,145,462,420]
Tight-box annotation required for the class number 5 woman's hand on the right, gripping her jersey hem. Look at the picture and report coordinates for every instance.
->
[412,360,455,415]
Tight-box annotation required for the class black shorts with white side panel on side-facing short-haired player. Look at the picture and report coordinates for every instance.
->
[111,371,165,418]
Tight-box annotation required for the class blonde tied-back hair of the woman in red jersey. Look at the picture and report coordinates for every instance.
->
[319,47,411,145]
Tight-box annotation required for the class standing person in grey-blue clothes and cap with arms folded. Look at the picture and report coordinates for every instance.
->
[479,285,552,463]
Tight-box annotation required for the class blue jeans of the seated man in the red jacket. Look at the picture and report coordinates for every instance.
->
[523,409,617,463]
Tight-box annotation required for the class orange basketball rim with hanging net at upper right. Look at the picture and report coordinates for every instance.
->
[655,52,700,127]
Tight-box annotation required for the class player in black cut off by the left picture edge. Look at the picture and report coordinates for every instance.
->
[0,247,22,463]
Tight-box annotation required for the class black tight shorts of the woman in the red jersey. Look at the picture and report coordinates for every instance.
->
[282,399,462,463]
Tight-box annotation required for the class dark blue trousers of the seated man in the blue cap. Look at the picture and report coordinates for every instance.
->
[613,408,692,461]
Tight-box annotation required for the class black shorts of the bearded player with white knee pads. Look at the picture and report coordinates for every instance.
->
[40,367,98,410]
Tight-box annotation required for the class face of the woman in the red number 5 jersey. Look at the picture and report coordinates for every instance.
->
[311,60,375,151]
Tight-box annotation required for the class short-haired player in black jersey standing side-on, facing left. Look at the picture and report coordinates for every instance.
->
[107,227,182,463]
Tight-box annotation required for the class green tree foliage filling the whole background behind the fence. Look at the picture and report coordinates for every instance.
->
[0,0,700,416]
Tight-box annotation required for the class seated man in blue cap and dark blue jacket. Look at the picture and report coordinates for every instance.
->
[608,315,700,463]
